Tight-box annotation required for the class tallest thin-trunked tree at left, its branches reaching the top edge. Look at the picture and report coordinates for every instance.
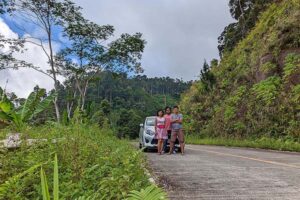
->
[0,0,82,121]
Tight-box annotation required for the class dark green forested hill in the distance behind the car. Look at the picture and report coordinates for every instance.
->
[0,71,192,138]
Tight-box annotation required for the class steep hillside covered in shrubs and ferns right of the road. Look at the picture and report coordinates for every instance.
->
[181,0,300,142]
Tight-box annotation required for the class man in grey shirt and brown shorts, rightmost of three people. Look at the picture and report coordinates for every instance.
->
[169,106,184,155]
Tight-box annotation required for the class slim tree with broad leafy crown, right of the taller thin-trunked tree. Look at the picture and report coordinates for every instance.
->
[58,19,145,111]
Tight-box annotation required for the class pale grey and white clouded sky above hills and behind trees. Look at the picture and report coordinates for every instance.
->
[0,0,233,97]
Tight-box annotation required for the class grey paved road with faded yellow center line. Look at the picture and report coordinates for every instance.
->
[146,145,300,200]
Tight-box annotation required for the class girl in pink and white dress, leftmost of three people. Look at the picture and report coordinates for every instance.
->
[155,110,168,155]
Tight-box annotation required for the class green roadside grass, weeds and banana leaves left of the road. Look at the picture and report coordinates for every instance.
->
[0,85,166,200]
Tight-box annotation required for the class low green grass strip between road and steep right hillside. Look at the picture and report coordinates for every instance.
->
[186,135,300,152]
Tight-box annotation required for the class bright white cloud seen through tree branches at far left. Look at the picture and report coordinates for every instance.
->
[0,18,59,97]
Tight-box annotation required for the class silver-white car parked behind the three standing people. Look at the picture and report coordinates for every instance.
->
[139,116,179,151]
